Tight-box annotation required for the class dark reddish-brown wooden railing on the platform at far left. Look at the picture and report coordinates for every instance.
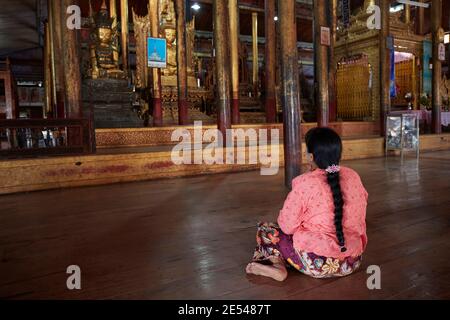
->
[0,119,95,159]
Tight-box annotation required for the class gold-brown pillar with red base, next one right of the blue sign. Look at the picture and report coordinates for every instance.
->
[175,0,189,125]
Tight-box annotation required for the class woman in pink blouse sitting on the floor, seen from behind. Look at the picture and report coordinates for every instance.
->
[246,128,367,281]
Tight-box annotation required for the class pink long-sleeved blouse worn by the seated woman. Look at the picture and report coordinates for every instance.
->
[278,167,368,260]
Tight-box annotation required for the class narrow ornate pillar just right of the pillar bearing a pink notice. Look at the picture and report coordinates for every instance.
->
[328,0,338,122]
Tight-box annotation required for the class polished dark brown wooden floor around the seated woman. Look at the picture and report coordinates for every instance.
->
[0,151,450,299]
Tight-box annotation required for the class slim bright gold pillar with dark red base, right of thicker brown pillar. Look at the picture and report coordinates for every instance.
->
[228,0,240,124]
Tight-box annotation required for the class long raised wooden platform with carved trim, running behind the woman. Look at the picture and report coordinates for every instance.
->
[0,122,450,194]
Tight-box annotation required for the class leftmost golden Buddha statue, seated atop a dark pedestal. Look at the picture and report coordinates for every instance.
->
[88,0,125,79]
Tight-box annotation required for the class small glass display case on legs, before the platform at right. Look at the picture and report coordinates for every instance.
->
[386,114,420,159]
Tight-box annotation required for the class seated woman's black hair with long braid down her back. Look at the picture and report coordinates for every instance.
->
[305,128,347,252]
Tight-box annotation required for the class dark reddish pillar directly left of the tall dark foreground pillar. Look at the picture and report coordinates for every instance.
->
[265,0,277,123]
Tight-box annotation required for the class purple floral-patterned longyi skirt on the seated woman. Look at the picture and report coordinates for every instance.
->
[253,223,362,278]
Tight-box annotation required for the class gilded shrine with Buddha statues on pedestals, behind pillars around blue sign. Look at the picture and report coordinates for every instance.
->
[78,0,215,128]
